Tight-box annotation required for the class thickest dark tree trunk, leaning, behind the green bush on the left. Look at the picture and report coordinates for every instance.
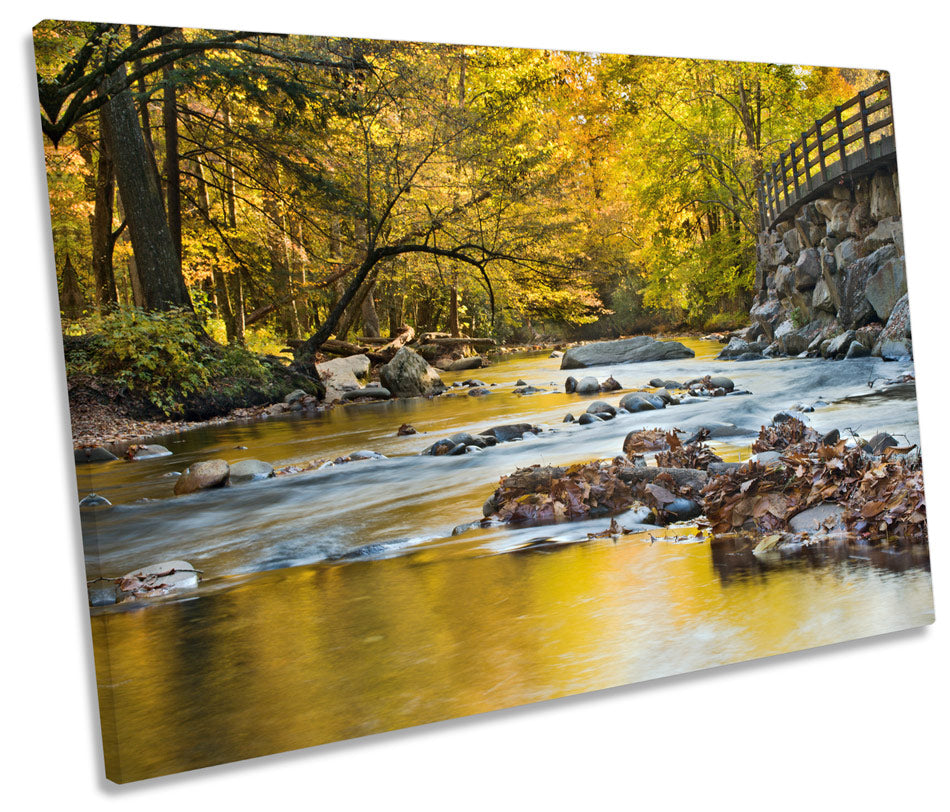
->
[102,65,192,310]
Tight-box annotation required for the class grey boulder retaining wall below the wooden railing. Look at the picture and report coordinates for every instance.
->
[721,170,913,360]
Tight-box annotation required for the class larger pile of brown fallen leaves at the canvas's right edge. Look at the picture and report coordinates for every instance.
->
[702,418,927,542]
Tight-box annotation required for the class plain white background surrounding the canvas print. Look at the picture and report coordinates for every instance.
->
[0,0,950,810]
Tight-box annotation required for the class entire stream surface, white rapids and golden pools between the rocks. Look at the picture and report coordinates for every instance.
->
[78,340,933,781]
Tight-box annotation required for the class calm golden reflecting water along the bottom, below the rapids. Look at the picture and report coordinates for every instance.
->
[93,540,933,781]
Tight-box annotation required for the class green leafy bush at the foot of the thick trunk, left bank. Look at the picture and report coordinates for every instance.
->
[67,307,273,416]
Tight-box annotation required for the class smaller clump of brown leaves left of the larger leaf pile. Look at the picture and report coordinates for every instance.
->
[486,457,636,524]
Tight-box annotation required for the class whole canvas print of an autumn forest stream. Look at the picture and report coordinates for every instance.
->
[34,21,933,782]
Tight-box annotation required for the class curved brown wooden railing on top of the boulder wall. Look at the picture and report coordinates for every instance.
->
[758,78,897,230]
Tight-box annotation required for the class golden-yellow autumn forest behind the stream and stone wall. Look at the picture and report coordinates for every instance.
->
[34,21,879,358]
